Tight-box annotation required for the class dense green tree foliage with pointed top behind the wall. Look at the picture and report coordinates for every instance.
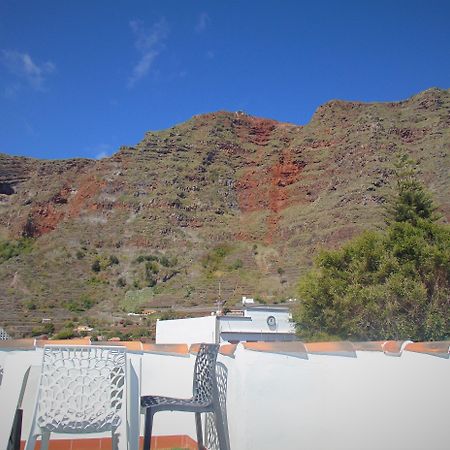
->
[295,157,450,340]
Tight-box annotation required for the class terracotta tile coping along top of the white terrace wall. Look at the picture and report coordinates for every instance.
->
[0,338,450,358]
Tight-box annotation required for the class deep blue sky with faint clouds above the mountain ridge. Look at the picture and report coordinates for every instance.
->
[0,0,450,158]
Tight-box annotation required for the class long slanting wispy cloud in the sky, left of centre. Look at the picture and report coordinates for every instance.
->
[128,18,169,88]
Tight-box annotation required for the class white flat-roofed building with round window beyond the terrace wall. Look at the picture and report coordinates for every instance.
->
[156,306,297,344]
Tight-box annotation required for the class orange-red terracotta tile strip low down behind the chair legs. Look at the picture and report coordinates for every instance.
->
[20,435,197,450]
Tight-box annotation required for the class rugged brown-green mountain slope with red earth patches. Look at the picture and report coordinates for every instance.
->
[0,88,450,334]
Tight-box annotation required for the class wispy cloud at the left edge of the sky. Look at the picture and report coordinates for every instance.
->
[0,49,56,95]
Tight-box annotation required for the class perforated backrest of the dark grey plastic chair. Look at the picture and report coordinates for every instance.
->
[192,344,219,403]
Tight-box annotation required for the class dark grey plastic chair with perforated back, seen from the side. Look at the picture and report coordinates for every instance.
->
[141,344,229,450]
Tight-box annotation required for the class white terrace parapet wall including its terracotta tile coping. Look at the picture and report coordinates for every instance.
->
[0,338,450,450]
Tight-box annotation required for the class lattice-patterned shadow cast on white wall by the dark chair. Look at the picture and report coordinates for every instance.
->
[205,362,230,450]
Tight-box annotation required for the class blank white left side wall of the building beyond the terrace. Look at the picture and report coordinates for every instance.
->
[156,316,216,344]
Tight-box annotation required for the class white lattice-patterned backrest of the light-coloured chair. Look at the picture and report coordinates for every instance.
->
[36,346,126,433]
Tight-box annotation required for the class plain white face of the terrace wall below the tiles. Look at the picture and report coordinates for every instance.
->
[0,345,450,450]
